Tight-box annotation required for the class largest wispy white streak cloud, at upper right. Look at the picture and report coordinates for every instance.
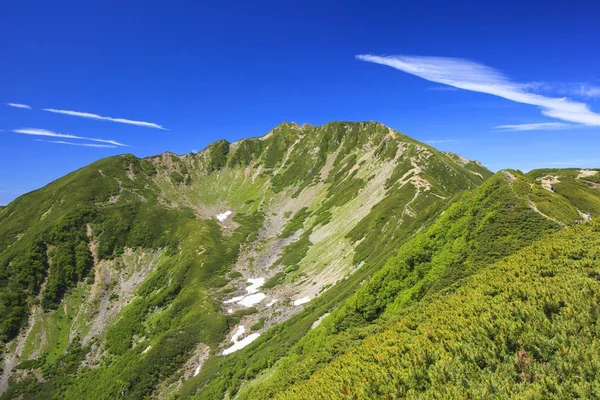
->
[356,55,600,126]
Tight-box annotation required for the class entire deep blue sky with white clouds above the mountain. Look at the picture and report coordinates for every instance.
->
[0,0,600,204]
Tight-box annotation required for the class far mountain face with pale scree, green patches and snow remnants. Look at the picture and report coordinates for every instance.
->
[0,122,485,398]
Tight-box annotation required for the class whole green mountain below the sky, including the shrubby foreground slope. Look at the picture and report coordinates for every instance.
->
[0,122,600,399]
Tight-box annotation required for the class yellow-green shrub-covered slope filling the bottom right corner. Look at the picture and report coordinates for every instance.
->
[268,222,600,399]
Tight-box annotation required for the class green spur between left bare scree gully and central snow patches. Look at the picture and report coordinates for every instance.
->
[2,214,262,398]
